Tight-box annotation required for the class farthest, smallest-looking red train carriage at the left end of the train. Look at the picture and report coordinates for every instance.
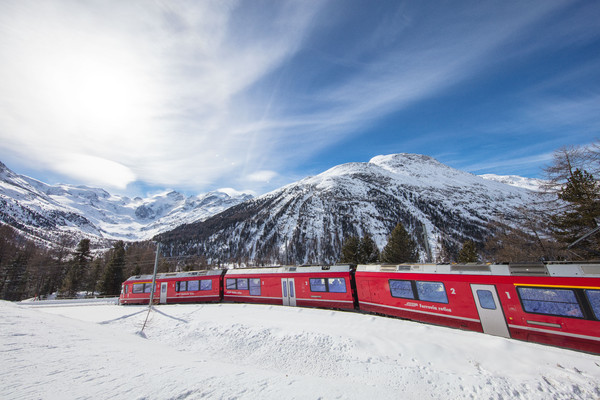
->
[119,270,223,304]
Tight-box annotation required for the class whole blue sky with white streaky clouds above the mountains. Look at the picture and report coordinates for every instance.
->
[0,0,600,195]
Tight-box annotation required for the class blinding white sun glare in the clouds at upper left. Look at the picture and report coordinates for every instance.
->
[38,40,152,136]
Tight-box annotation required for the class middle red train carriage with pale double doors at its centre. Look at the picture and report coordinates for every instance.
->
[223,265,355,310]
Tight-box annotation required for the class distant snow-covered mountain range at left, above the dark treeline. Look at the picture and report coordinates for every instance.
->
[0,163,252,243]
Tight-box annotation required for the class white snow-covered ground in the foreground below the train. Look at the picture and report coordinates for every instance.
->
[0,302,600,399]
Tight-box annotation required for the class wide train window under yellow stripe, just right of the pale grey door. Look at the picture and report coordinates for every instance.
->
[517,287,583,318]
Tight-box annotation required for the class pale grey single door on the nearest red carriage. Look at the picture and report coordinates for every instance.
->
[471,284,510,338]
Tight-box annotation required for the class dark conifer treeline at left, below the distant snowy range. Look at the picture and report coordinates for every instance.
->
[0,230,190,301]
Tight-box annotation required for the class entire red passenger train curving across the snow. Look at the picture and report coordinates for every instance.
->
[120,263,600,354]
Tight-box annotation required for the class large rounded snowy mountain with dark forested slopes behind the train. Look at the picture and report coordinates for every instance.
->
[159,154,544,264]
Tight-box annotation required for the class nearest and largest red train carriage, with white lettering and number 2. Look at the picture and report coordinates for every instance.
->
[356,263,600,353]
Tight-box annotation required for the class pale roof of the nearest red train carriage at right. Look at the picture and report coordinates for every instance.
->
[356,263,600,277]
